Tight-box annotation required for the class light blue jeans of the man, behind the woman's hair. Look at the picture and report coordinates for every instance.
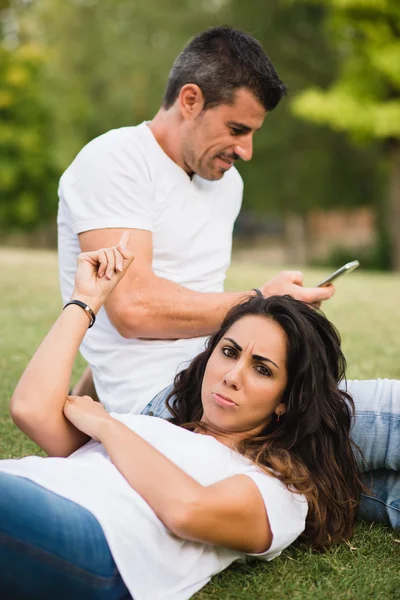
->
[143,379,400,529]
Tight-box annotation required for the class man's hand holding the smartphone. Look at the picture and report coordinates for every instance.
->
[260,271,335,306]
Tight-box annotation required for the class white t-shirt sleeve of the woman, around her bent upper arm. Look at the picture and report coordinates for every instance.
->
[245,469,308,560]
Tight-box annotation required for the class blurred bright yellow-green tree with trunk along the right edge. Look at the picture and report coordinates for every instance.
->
[292,0,400,271]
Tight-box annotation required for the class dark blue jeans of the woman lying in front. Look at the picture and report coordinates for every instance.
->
[0,472,131,600]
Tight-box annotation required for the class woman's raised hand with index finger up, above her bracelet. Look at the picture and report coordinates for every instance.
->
[71,231,134,312]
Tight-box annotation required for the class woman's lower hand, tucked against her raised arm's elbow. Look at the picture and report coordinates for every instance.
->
[63,396,113,441]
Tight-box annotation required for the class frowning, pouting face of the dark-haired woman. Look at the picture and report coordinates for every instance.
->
[201,315,287,438]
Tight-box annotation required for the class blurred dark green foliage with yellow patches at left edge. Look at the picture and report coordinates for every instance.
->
[0,39,57,229]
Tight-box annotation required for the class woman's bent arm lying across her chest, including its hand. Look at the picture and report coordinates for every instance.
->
[64,397,272,553]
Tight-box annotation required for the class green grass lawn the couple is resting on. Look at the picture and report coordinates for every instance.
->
[0,250,400,600]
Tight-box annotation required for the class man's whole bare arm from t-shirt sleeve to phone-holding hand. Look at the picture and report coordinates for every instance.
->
[79,229,333,339]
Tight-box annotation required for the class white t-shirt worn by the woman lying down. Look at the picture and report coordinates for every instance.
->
[0,414,308,600]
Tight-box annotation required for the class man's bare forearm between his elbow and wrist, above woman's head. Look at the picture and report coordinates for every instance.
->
[106,276,252,339]
